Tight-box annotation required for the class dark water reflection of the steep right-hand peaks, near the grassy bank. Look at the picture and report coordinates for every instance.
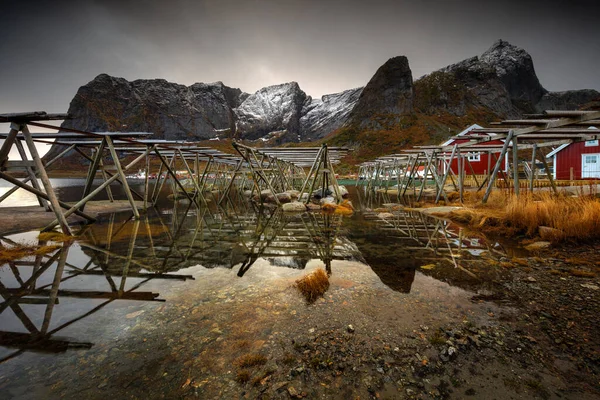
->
[350,195,506,292]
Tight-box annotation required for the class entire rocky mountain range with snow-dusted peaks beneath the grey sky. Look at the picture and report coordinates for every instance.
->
[47,40,600,162]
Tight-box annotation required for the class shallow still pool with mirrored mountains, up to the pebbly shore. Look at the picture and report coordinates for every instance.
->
[0,186,514,398]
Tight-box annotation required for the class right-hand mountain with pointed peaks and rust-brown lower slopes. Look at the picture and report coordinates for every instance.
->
[327,40,600,163]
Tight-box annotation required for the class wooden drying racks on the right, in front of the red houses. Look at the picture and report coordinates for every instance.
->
[357,111,600,203]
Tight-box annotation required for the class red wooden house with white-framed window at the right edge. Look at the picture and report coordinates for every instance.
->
[546,127,600,180]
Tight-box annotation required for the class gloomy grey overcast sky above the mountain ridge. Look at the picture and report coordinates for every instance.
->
[0,0,600,113]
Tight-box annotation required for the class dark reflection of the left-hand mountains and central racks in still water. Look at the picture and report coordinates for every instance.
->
[79,205,361,276]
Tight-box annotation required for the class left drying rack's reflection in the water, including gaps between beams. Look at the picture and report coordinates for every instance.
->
[0,238,193,362]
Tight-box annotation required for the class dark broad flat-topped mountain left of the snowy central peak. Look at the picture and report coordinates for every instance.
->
[56,74,244,140]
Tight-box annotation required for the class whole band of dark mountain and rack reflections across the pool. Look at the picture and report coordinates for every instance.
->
[0,186,516,362]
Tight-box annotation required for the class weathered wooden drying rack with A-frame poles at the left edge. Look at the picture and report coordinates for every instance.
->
[0,111,241,235]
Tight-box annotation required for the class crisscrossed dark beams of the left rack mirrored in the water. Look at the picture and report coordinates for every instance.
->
[0,228,194,362]
